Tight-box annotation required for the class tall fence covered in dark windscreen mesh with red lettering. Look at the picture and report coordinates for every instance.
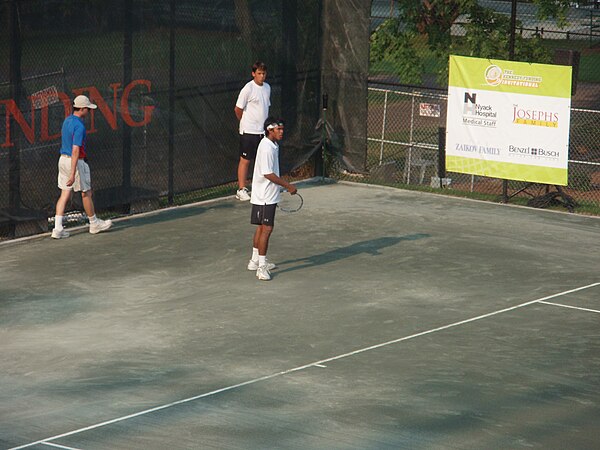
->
[0,0,370,239]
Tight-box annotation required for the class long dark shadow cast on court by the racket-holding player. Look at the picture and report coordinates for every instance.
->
[274,233,431,275]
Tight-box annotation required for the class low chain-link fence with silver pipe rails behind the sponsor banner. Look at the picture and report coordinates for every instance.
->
[336,84,600,213]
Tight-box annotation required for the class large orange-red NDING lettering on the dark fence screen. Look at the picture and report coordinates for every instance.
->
[0,80,154,147]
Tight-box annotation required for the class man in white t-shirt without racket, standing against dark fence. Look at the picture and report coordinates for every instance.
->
[234,61,271,201]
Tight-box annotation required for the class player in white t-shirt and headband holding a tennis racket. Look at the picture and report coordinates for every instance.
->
[248,117,297,281]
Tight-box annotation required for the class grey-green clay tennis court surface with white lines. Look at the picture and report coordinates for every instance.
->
[0,180,600,449]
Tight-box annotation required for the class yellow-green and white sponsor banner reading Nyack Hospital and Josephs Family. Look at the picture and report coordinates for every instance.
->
[446,56,571,185]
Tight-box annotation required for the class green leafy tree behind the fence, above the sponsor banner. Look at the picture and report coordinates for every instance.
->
[371,0,569,84]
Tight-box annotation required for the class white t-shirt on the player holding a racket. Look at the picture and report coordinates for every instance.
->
[250,137,281,205]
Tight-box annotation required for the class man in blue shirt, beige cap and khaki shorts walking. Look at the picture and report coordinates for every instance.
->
[52,95,112,239]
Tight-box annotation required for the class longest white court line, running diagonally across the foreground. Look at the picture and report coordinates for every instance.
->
[9,282,600,450]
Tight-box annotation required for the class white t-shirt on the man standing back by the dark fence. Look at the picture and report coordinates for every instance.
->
[235,80,271,134]
